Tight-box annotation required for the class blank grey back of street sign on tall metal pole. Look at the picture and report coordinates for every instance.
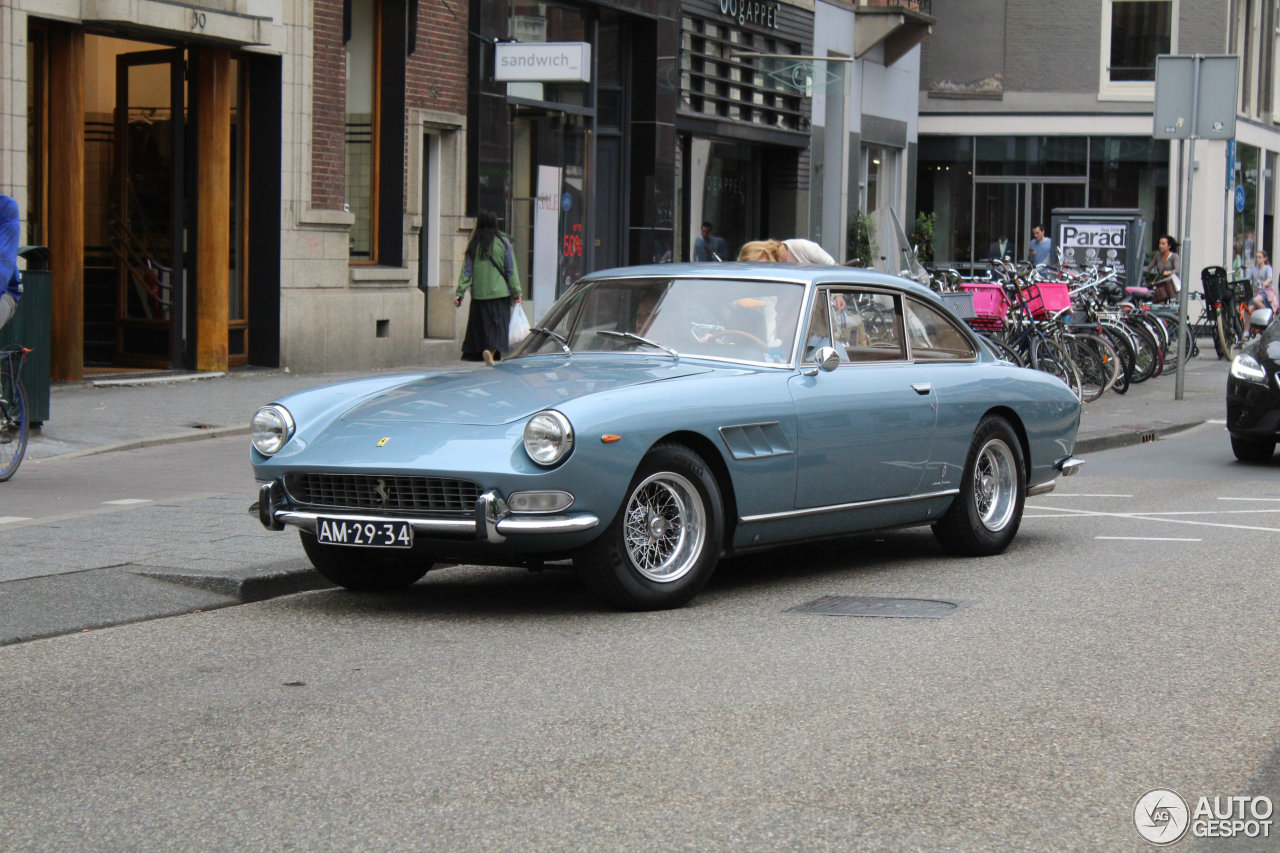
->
[1152,54,1240,400]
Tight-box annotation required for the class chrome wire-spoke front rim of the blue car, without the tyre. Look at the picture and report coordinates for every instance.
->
[623,471,707,583]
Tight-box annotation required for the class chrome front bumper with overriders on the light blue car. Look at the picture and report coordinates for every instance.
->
[257,482,600,544]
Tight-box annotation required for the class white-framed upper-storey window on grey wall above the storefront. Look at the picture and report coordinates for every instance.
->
[1100,0,1178,100]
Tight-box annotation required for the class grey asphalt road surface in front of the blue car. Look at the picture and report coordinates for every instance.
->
[0,425,1280,850]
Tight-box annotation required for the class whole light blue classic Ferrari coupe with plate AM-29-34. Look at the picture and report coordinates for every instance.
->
[252,264,1083,610]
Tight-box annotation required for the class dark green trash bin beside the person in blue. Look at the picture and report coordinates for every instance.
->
[0,246,54,427]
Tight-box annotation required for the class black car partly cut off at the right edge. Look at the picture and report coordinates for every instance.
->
[1226,323,1280,462]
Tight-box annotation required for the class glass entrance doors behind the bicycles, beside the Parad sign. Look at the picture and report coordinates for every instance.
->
[972,178,1087,261]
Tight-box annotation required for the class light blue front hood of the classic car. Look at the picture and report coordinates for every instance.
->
[338,357,710,427]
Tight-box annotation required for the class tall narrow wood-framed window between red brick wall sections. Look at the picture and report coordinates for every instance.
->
[344,0,379,263]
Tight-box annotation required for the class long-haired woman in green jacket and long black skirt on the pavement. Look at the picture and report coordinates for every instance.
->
[453,210,524,365]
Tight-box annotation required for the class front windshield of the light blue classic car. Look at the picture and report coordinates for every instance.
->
[512,278,804,364]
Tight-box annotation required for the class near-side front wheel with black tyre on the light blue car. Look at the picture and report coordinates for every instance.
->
[573,444,724,610]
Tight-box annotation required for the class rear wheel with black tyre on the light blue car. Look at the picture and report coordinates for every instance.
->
[933,415,1027,557]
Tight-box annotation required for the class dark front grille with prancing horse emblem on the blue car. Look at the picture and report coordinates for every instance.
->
[284,474,480,515]
